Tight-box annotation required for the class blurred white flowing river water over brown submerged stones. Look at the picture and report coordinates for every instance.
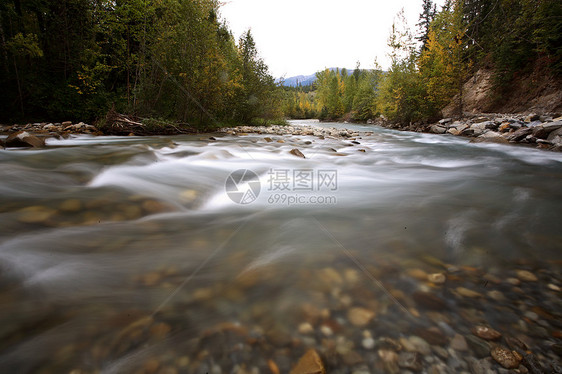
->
[0,121,562,374]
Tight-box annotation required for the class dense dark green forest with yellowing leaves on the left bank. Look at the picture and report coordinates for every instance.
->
[0,0,282,127]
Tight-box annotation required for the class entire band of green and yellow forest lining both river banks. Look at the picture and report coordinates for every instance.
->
[0,0,562,128]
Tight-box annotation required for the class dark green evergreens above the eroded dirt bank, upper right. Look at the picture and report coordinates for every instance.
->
[462,0,562,87]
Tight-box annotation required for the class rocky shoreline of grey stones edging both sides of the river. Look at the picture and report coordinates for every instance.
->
[4,114,562,152]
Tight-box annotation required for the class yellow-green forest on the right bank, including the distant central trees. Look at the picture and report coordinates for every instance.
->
[284,0,562,123]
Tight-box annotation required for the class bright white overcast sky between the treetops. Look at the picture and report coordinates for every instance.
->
[220,0,444,78]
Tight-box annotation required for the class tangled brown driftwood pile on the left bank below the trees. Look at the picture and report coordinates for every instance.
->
[101,109,197,135]
